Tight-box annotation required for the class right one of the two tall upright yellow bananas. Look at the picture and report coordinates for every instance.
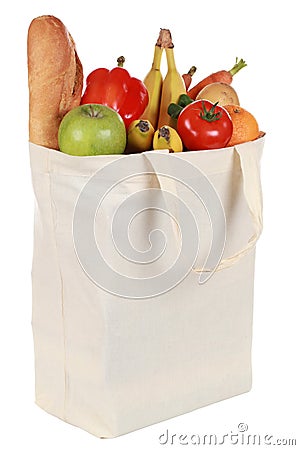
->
[158,34,186,129]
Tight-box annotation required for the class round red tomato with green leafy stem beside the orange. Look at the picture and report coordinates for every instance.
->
[177,100,233,150]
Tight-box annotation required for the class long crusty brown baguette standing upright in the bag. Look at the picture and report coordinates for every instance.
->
[27,15,83,149]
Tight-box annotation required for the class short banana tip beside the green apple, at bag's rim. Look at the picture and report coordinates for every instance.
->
[125,119,154,153]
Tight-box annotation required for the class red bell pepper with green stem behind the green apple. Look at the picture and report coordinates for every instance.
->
[81,56,149,128]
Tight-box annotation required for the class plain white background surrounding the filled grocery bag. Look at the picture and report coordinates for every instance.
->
[0,0,300,450]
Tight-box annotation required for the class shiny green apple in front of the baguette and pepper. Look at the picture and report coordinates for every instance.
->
[58,104,126,156]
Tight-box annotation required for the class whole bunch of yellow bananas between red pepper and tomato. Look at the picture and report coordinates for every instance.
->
[127,28,186,153]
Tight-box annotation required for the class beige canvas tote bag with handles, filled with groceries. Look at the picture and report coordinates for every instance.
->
[30,137,264,438]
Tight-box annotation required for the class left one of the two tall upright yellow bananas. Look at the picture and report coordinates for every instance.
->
[141,32,163,129]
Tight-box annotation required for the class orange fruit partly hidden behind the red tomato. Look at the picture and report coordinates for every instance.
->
[223,105,260,147]
